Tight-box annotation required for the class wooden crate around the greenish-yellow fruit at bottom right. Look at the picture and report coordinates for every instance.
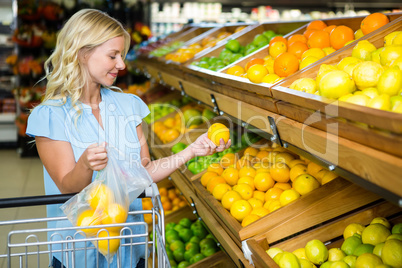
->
[247,201,402,268]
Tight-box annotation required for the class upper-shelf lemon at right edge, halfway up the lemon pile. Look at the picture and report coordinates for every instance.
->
[377,66,402,96]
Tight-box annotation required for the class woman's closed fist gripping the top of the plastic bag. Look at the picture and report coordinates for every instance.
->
[81,142,108,171]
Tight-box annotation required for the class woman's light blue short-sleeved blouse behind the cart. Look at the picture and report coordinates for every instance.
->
[26,88,149,267]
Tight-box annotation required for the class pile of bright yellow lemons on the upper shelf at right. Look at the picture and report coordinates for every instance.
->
[290,31,402,113]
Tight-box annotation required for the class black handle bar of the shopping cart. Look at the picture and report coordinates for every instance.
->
[0,192,145,209]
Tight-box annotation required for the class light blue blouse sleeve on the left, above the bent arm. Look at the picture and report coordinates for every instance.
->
[26,105,68,141]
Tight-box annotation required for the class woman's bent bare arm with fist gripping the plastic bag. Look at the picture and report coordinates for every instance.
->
[35,136,108,194]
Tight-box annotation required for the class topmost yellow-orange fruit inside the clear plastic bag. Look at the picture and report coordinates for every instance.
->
[86,183,114,210]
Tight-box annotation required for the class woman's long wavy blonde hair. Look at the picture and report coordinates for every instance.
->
[43,9,130,114]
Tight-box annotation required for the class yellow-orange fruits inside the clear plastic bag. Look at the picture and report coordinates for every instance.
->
[76,183,128,256]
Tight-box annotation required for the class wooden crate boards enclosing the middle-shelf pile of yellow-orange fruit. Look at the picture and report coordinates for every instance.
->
[193,175,380,245]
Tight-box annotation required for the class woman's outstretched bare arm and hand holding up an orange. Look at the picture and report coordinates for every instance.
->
[137,124,231,182]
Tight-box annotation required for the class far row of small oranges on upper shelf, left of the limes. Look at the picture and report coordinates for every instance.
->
[165,31,232,63]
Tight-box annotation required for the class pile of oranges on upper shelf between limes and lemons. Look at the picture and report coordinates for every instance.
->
[226,13,389,84]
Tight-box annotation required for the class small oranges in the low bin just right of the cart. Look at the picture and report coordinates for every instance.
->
[142,187,187,223]
